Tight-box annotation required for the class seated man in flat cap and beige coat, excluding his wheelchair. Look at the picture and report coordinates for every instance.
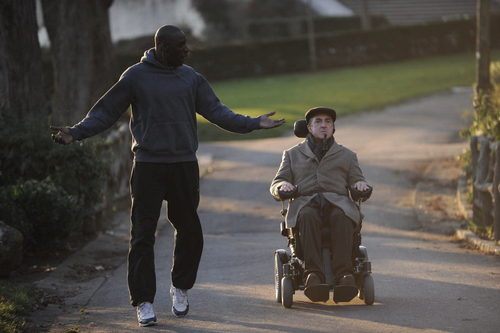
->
[270,107,370,302]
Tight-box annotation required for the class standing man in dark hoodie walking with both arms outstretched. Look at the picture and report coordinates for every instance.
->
[50,25,285,326]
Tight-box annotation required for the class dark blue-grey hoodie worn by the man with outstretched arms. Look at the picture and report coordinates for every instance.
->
[70,48,260,163]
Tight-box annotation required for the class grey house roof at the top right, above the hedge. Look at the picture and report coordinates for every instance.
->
[337,0,500,25]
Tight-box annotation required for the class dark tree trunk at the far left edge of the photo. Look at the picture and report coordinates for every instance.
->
[0,0,46,119]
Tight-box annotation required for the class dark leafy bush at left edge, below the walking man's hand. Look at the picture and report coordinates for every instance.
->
[0,117,105,249]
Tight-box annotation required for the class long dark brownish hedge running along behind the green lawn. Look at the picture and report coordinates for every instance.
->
[117,14,500,80]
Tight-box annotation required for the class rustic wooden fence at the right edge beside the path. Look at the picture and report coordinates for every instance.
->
[470,135,500,241]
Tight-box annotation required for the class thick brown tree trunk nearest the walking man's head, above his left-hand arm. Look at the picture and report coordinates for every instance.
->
[42,0,115,125]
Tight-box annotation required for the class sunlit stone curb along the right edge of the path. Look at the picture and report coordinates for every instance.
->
[455,175,500,256]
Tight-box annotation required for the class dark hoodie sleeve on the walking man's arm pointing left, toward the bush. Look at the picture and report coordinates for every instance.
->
[69,76,133,141]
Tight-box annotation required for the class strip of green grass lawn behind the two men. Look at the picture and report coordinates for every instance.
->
[198,51,500,141]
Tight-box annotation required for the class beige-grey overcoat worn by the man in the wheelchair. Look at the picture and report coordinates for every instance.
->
[270,139,366,228]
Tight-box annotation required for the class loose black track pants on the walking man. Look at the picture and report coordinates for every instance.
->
[128,162,203,306]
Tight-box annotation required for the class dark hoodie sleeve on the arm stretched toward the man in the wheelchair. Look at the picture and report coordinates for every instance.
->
[196,74,260,133]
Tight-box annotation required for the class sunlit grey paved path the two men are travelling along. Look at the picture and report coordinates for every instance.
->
[43,90,500,333]
